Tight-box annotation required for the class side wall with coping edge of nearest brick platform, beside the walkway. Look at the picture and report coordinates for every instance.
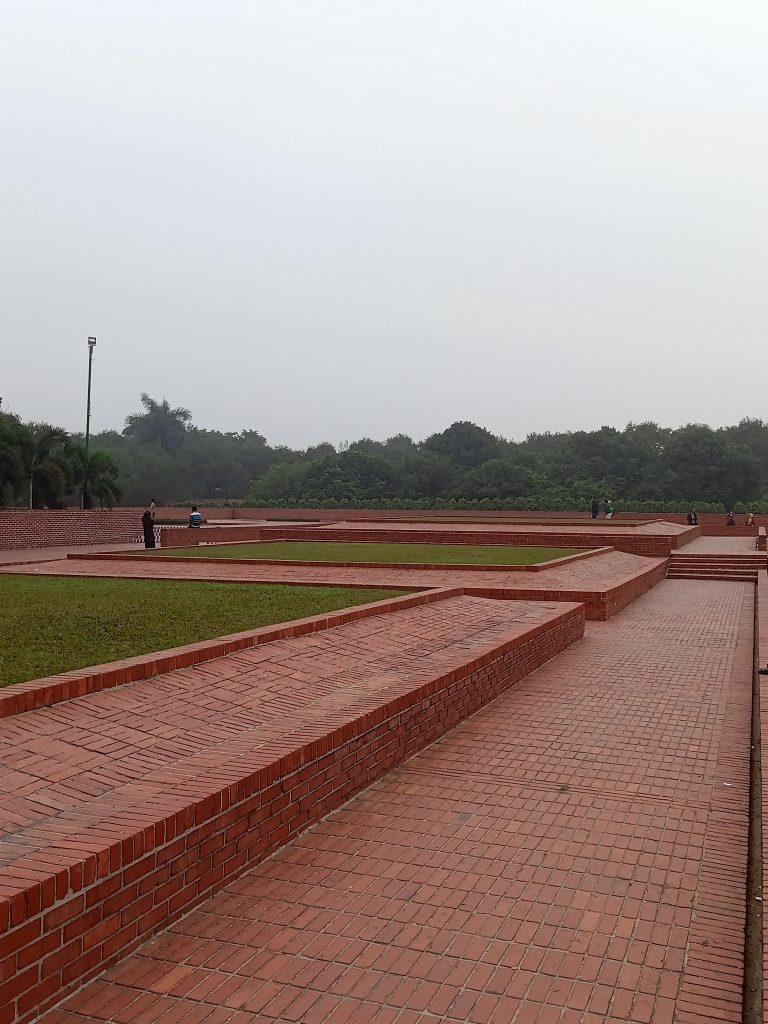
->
[0,604,584,1024]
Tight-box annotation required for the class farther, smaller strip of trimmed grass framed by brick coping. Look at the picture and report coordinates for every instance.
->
[158,541,584,565]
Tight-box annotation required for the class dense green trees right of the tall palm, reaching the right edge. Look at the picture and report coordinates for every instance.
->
[247,420,768,511]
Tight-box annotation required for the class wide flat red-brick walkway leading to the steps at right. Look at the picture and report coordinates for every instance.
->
[43,582,754,1024]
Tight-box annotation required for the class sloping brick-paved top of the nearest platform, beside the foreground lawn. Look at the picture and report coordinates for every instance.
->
[0,597,562,879]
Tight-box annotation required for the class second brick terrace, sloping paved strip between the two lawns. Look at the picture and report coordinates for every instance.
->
[0,549,667,618]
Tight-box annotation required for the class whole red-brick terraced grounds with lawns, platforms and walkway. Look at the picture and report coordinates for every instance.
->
[0,510,768,1024]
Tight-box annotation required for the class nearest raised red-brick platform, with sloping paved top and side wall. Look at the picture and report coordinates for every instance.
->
[0,595,584,1024]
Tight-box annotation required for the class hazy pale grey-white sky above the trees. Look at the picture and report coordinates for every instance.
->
[0,0,768,446]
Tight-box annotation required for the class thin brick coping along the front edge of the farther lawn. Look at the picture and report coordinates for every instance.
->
[67,541,615,572]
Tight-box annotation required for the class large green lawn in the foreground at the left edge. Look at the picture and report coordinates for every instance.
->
[0,575,403,686]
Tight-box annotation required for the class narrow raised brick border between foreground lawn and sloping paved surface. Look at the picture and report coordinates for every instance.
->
[0,573,456,719]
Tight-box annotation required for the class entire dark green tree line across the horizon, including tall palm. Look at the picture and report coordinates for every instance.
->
[0,394,768,512]
